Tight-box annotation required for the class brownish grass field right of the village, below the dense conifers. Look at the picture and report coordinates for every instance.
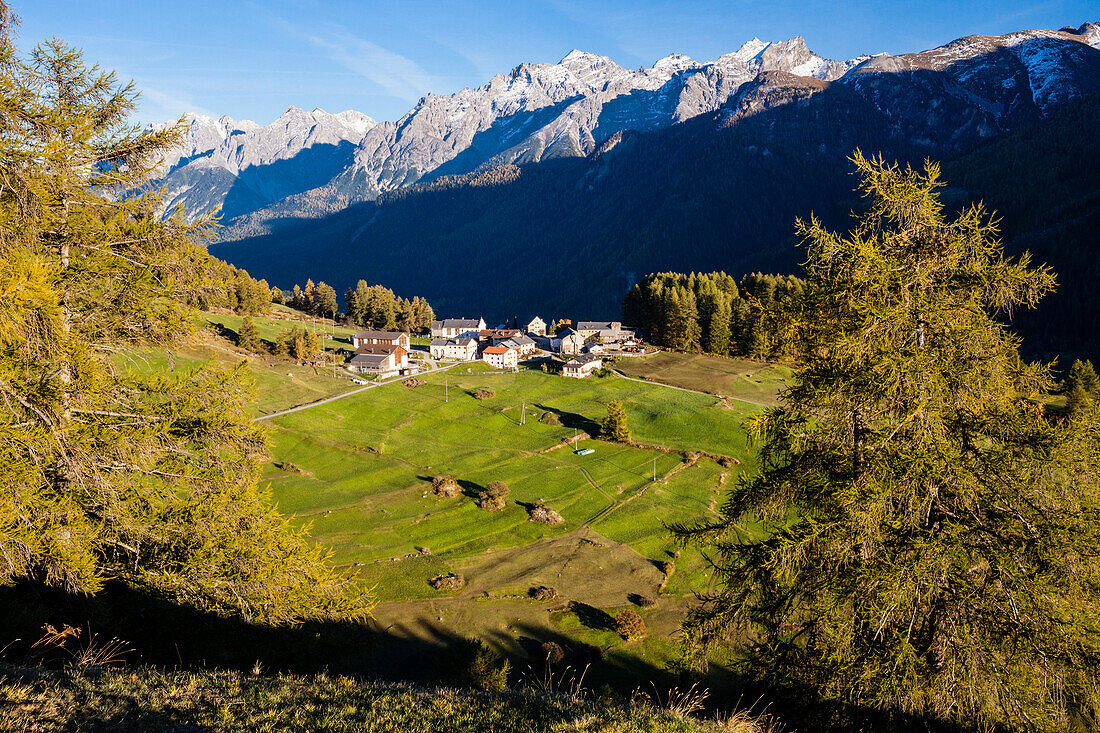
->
[615,351,791,405]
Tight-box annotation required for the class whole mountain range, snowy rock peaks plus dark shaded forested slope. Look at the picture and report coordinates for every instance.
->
[163,23,1100,360]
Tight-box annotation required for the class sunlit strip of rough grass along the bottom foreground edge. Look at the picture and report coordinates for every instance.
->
[0,667,751,733]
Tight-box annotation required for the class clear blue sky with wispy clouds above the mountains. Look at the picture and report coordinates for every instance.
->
[11,0,1100,124]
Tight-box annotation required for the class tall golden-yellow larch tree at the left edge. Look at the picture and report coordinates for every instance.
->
[0,15,370,624]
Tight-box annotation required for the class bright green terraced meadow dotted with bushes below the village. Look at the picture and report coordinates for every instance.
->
[265,364,759,668]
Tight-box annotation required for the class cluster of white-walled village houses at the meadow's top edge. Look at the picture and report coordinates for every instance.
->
[344,316,645,379]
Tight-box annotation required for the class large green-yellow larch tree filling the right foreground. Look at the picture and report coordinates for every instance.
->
[677,154,1100,731]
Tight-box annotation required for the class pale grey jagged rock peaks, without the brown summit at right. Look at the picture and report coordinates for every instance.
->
[150,36,871,222]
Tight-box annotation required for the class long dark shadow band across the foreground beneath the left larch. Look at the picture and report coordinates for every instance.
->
[0,582,994,733]
